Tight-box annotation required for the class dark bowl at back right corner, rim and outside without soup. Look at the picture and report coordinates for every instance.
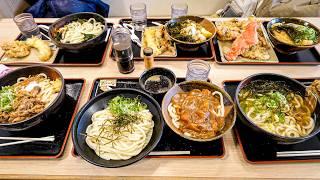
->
[267,18,320,54]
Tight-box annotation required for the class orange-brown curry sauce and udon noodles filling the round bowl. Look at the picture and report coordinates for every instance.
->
[168,89,225,139]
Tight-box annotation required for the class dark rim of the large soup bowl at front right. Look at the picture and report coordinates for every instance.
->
[235,73,320,142]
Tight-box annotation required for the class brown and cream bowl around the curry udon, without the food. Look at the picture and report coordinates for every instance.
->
[161,81,236,142]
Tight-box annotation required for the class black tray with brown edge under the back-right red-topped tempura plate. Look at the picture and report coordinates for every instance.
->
[213,22,320,65]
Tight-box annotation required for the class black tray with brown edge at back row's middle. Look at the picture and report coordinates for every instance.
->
[110,18,215,61]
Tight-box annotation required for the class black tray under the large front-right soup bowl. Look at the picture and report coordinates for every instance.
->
[223,79,320,164]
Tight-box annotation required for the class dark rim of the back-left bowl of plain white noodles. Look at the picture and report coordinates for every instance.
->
[48,12,108,46]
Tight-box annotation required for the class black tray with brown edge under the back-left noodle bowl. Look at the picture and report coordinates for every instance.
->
[0,23,113,67]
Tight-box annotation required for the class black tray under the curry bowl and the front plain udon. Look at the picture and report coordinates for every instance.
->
[73,78,225,158]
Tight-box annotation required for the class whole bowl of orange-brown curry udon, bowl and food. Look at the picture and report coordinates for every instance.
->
[162,81,236,142]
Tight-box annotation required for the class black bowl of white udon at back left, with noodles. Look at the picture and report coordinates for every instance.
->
[49,12,107,52]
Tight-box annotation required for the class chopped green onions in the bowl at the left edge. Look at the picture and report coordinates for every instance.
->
[0,86,15,112]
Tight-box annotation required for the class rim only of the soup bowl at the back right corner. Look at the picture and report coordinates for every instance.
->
[266,17,320,48]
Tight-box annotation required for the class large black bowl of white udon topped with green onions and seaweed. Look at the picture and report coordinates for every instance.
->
[72,88,164,168]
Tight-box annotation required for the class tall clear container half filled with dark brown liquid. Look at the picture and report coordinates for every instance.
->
[111,27,134,74]
